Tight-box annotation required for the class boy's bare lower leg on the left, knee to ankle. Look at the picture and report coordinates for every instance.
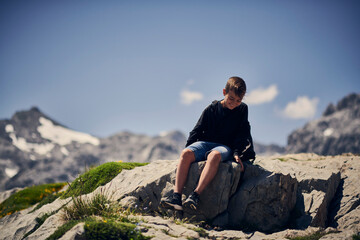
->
[174,149,195,194]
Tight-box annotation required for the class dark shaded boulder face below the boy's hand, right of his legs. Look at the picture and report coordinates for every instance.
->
[228,165,298,232]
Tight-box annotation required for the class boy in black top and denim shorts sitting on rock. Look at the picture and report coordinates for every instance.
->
[160,77,255,210]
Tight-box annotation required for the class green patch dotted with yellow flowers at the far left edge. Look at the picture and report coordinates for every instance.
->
[0,183,66,217]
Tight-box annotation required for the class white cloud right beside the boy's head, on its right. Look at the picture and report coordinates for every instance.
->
[244,85,279,105]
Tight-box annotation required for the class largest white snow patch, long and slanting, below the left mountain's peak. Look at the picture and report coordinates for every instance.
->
[37,117,100,146]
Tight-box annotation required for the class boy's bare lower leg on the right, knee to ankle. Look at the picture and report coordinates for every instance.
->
[194,151,221,194]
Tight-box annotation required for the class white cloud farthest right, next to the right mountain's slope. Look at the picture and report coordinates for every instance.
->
[283,96,319,119]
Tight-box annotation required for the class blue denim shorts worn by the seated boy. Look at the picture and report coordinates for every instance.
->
[186,141,232,162]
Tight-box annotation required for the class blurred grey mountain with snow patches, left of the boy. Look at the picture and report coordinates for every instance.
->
[0,107,186,191]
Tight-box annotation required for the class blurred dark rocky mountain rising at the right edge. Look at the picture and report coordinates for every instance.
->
[286,93,360,155]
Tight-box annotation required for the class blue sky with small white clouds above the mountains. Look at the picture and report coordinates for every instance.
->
[0,0,360,145]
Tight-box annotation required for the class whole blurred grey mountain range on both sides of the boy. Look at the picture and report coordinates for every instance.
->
[0,94,360,191]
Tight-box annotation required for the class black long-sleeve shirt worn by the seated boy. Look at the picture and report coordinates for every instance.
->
[186,101,255,160]
